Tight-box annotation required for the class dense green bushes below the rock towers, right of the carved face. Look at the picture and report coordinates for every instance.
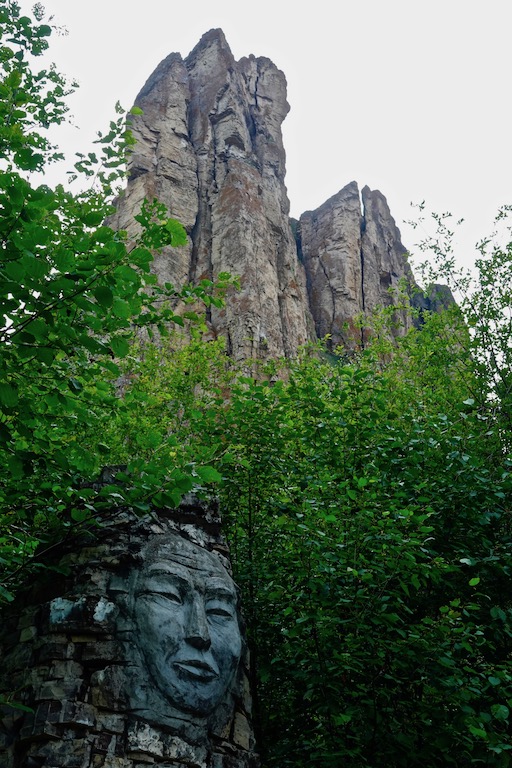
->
[117,300,512,768]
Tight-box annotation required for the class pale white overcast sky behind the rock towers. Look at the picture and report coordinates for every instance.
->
[21,0,512,270]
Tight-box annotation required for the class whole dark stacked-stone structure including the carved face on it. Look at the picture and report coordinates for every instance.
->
[0,498,257,768]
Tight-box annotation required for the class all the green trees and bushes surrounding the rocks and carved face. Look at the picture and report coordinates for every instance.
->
[0,0,512,768]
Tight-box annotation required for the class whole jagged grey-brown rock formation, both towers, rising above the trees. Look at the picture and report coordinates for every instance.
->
[113,30,448,360]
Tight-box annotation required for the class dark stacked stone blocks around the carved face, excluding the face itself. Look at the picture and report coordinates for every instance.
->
[0,498,257,768]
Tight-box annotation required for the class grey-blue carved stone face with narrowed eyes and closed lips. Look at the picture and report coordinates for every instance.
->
[134,535,242,717]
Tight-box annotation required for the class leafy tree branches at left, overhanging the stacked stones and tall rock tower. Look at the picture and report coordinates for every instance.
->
[0,0,235,600]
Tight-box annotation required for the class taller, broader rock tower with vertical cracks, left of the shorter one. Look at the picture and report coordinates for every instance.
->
[115,30,312,359]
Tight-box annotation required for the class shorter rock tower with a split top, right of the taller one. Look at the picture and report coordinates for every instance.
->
[297,181,414,346]
